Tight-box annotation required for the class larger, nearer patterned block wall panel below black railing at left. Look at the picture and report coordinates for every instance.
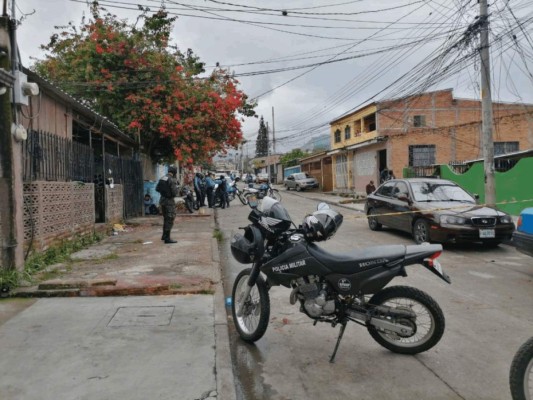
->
[23,181,95,250]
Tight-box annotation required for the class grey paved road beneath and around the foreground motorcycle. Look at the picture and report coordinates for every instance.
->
[218,192,533,400]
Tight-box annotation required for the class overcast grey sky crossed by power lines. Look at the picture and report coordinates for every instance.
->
[8,0,533,156]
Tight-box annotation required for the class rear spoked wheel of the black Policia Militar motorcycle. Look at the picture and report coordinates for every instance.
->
[368,286,445,354]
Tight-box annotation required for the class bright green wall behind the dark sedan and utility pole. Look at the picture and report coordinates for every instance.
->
[440,157,533,215]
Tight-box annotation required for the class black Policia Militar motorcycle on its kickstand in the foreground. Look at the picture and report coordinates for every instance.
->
[230,197,451,363]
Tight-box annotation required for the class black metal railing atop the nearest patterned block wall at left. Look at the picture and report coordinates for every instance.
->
[22,131,95,182]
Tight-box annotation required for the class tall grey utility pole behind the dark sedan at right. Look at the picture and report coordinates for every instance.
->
[479,0,496,206]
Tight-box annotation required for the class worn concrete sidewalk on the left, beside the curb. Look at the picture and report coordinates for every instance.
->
[0,212,236,400]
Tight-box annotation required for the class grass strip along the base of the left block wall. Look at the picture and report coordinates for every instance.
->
[0,233,102,294]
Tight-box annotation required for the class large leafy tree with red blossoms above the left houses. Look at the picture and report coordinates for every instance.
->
[34,2,255,163]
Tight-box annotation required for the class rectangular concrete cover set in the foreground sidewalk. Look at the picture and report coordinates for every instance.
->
[107,306,174,327]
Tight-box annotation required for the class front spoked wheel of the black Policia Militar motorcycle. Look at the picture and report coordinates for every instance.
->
[231,268,270,342]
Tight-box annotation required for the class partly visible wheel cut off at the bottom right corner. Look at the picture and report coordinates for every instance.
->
[509,337,533,400]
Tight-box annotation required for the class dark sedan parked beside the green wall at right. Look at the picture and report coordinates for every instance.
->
[365,178,515,247]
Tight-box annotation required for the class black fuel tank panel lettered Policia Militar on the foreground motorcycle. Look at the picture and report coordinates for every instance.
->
[261,240,331,287]
